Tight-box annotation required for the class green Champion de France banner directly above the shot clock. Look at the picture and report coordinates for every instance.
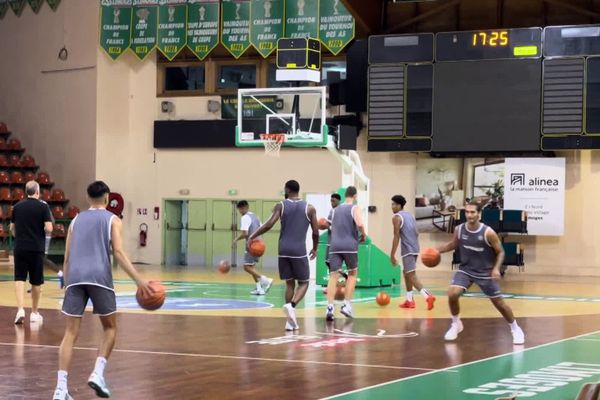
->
[285,0,319,39]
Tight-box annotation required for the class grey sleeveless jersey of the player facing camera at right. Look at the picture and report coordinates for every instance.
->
[458,224,496,278]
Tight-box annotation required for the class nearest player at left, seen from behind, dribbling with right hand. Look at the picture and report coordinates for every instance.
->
[52,181,152,400]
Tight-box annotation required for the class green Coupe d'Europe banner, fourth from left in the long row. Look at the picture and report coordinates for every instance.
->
[188,0,219,60]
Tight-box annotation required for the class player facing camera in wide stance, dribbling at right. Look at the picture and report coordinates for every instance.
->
[438,202,525,344]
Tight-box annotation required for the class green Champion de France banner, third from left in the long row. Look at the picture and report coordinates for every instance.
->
[158,0,187,61]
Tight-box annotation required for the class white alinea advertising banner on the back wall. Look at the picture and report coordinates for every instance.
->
[504,158,565,236]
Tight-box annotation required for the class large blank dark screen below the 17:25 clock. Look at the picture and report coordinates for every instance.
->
[432,59,542,153]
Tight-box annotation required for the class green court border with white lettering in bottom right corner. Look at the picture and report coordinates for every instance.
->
[327,332,600,400]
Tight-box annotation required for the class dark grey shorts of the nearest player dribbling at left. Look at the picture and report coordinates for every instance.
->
[62,285,117,317]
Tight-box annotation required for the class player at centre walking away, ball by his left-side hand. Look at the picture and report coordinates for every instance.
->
[248,180,319,331]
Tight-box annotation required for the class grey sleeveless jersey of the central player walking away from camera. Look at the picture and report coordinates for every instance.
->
[279,199,310,258]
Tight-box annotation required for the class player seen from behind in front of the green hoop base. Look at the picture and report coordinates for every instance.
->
[325,186,367,321]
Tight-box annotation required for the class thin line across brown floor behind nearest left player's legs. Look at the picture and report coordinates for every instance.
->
[0,342,436,372]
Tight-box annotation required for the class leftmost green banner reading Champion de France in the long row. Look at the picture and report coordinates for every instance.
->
[100,0,131,60]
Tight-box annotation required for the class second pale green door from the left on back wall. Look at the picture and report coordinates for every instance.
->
[187,200,207,266]
